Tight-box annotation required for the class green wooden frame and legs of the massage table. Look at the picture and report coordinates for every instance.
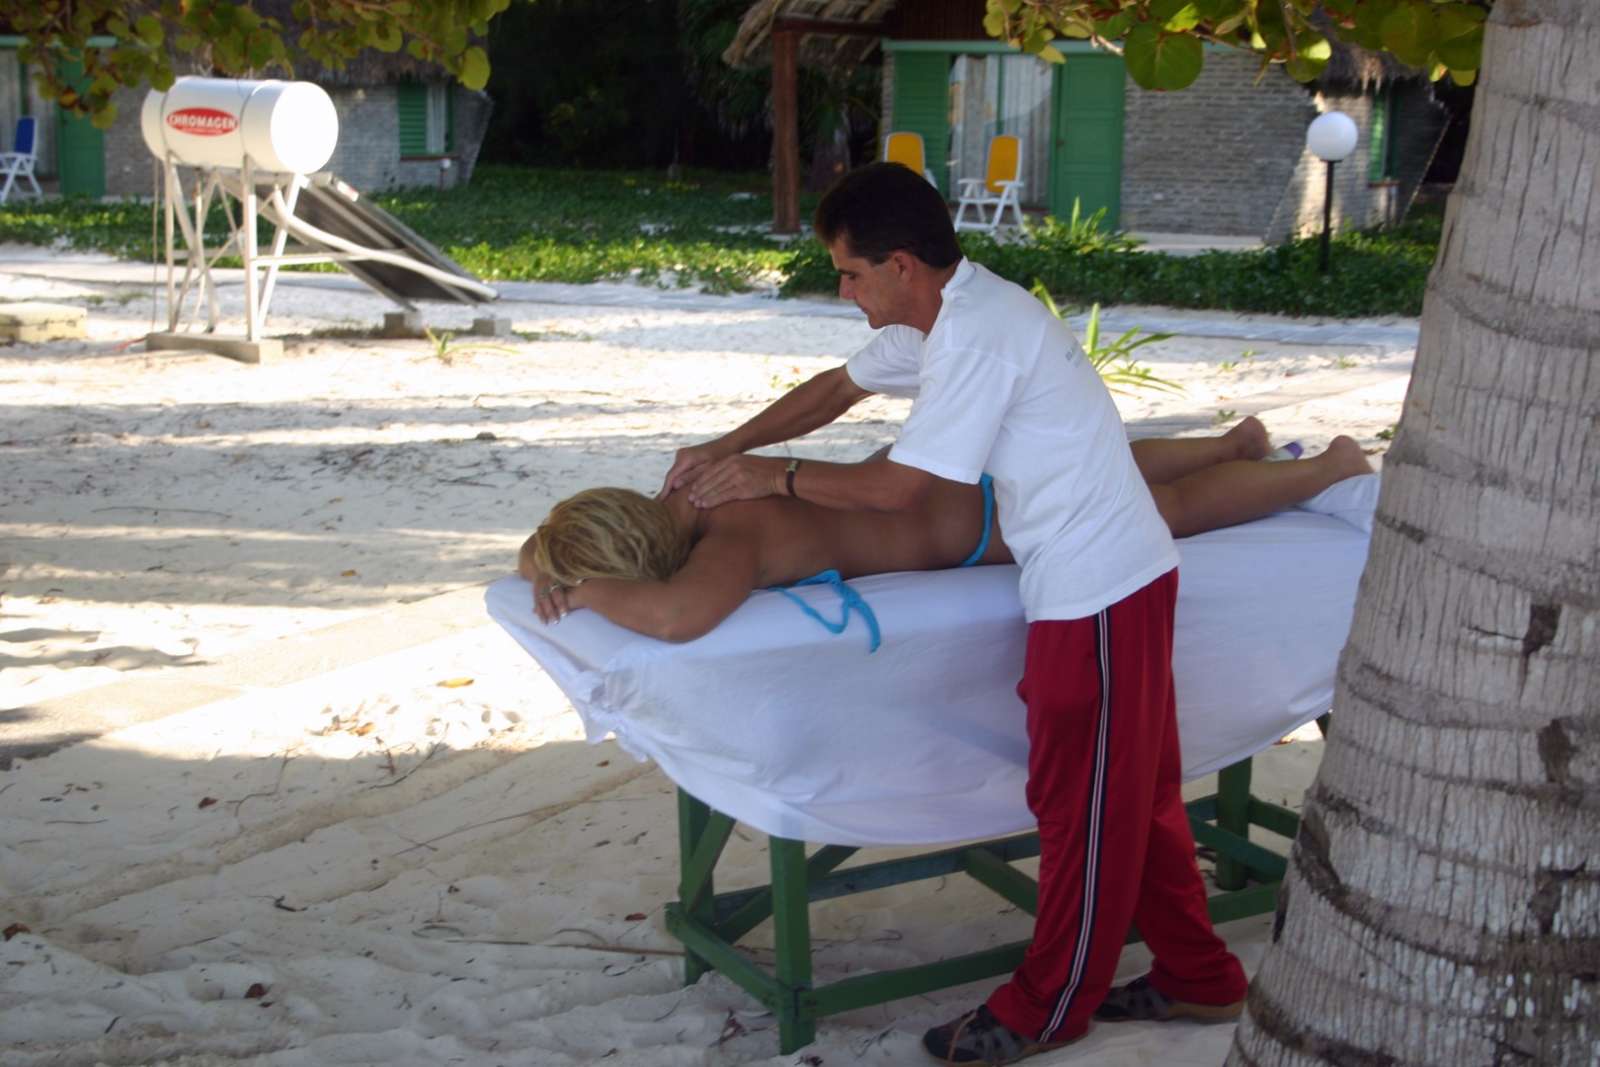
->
[666,760,1299,1054]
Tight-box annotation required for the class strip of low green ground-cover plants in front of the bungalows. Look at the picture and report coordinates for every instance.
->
[0,166,1442,317]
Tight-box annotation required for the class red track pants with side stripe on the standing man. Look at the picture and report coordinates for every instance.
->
[989,571,1246,1041]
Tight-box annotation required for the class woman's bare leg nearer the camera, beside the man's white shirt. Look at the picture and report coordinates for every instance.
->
[1150,437,1373,537]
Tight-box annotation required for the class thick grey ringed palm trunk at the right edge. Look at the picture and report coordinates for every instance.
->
[1229,0,1600,1067]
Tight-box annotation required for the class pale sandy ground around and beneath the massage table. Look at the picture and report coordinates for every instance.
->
[0,248,1411,1067]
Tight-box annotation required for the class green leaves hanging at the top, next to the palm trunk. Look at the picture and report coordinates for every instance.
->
[984,0,1493,90]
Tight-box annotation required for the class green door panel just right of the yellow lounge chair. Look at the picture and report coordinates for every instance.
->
[1050,53,1126,229]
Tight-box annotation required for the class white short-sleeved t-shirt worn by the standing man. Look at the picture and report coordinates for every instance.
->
[845,259,1178,622]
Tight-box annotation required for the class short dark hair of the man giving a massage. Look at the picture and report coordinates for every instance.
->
[811,163,962,267]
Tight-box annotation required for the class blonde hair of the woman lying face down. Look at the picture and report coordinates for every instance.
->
[520,488,690,585]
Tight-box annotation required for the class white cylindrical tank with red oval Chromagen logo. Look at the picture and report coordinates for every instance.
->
[139,78,339,174]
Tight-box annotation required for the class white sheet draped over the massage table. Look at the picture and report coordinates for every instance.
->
[486,475,1378,845]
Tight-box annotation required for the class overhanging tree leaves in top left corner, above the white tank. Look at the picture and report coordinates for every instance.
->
[0,0,510,128]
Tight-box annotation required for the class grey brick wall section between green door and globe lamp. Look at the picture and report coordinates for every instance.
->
[1122,50,1317,237]
